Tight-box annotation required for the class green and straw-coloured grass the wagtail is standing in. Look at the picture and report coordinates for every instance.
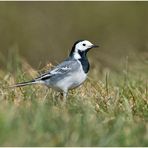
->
[0,55,148,146]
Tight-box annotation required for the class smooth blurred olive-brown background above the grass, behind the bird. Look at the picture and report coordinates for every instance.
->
[0,1,148,72]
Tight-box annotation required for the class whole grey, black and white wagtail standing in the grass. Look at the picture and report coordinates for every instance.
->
[13,40,98,99]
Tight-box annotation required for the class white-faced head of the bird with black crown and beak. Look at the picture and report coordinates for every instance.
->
[70,40,99,59]
